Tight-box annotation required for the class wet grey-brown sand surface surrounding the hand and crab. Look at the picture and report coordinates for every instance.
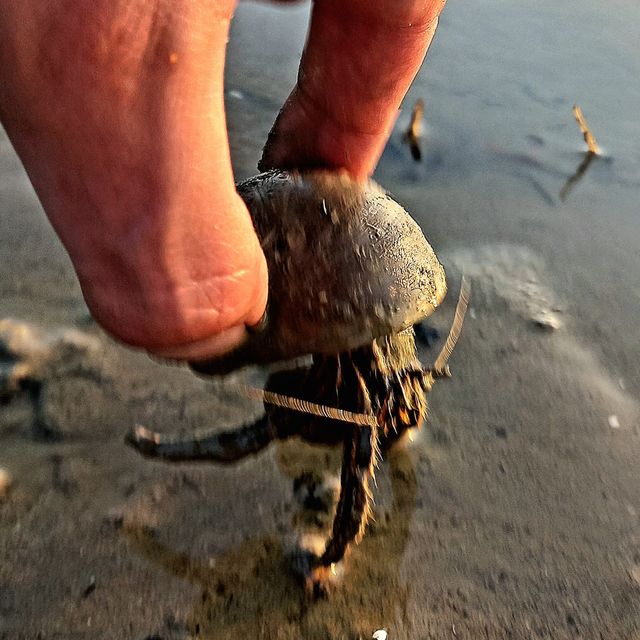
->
[0,0,640,640]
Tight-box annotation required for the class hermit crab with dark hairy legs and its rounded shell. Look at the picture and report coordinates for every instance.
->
[127,171,468,591]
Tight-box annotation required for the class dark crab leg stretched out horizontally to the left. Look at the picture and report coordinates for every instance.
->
[126,415,277,463]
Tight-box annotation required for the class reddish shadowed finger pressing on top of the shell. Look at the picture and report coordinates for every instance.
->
[260,0,445,179]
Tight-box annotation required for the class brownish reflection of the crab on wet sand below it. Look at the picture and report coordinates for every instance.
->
[123,447,418,640]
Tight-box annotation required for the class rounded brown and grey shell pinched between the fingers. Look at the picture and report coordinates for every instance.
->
[191,171,447,374]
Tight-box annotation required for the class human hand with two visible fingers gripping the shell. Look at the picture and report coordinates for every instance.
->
[0,0,444,359]
